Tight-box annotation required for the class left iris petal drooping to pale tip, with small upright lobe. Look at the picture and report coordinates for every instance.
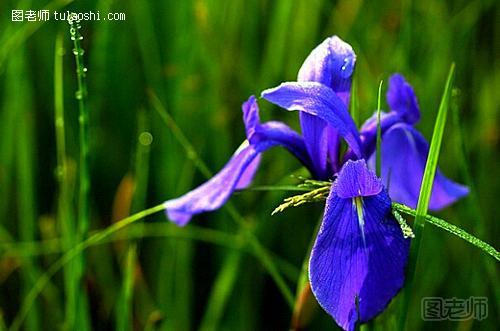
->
[165,96,311,226]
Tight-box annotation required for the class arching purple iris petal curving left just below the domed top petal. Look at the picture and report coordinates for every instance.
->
[262,82,361,157]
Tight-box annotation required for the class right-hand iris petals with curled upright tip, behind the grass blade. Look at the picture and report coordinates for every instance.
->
[361,74,469,210]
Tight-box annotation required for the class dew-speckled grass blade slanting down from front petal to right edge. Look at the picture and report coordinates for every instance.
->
[393,203,500,261]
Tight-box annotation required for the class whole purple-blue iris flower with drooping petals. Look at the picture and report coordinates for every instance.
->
[165,36,467,330]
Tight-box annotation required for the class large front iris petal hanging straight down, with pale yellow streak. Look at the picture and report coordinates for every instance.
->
[309,160,409,330]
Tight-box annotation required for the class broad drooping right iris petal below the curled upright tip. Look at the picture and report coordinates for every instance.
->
[369,123,468,210]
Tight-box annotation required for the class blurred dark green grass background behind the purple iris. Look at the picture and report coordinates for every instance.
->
[0,0,500,330]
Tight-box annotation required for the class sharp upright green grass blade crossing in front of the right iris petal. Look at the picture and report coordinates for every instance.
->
[399,63,455,330]
